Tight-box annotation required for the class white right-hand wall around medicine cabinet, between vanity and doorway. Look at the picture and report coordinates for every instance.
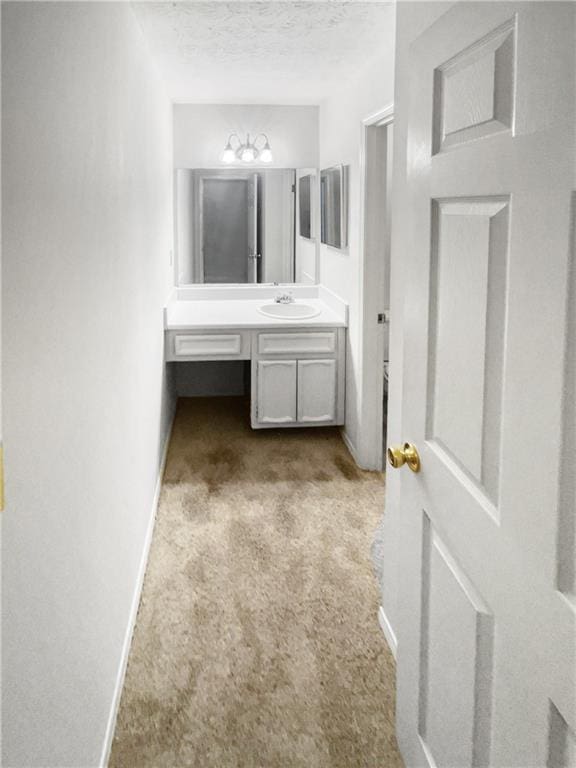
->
[320,27,394,456]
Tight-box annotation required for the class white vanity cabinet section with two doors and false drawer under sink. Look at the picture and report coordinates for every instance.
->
[252,328,345,429]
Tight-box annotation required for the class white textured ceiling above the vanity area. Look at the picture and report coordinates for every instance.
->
[133,0,394,104]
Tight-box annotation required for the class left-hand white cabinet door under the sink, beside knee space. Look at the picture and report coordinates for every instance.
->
[257,360,297,424]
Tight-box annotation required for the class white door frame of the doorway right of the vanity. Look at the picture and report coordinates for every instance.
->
[357,103,394,470]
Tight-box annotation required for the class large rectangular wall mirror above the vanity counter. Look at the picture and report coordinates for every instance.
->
[176,168,316,285]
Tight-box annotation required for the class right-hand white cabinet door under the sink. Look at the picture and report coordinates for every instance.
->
[298,360,336,422]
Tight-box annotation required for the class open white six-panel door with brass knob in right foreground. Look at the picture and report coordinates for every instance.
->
[397,2,576,768]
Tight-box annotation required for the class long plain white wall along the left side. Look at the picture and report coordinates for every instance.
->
[2,2,172,768]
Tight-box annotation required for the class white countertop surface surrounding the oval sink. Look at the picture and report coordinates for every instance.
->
[165,297,347,331]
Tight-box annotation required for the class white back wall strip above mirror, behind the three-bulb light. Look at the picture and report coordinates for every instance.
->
[174,104,318,168]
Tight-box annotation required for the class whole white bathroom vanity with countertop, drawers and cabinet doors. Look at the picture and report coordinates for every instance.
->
[165,286,347,429]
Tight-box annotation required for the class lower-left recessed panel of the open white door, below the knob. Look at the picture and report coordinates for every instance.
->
[419,514,493,768]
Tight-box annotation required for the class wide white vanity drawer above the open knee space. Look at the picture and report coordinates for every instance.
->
[166,331,250,360]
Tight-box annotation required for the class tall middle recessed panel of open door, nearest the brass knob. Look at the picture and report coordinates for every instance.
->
[426,198,509,503]
